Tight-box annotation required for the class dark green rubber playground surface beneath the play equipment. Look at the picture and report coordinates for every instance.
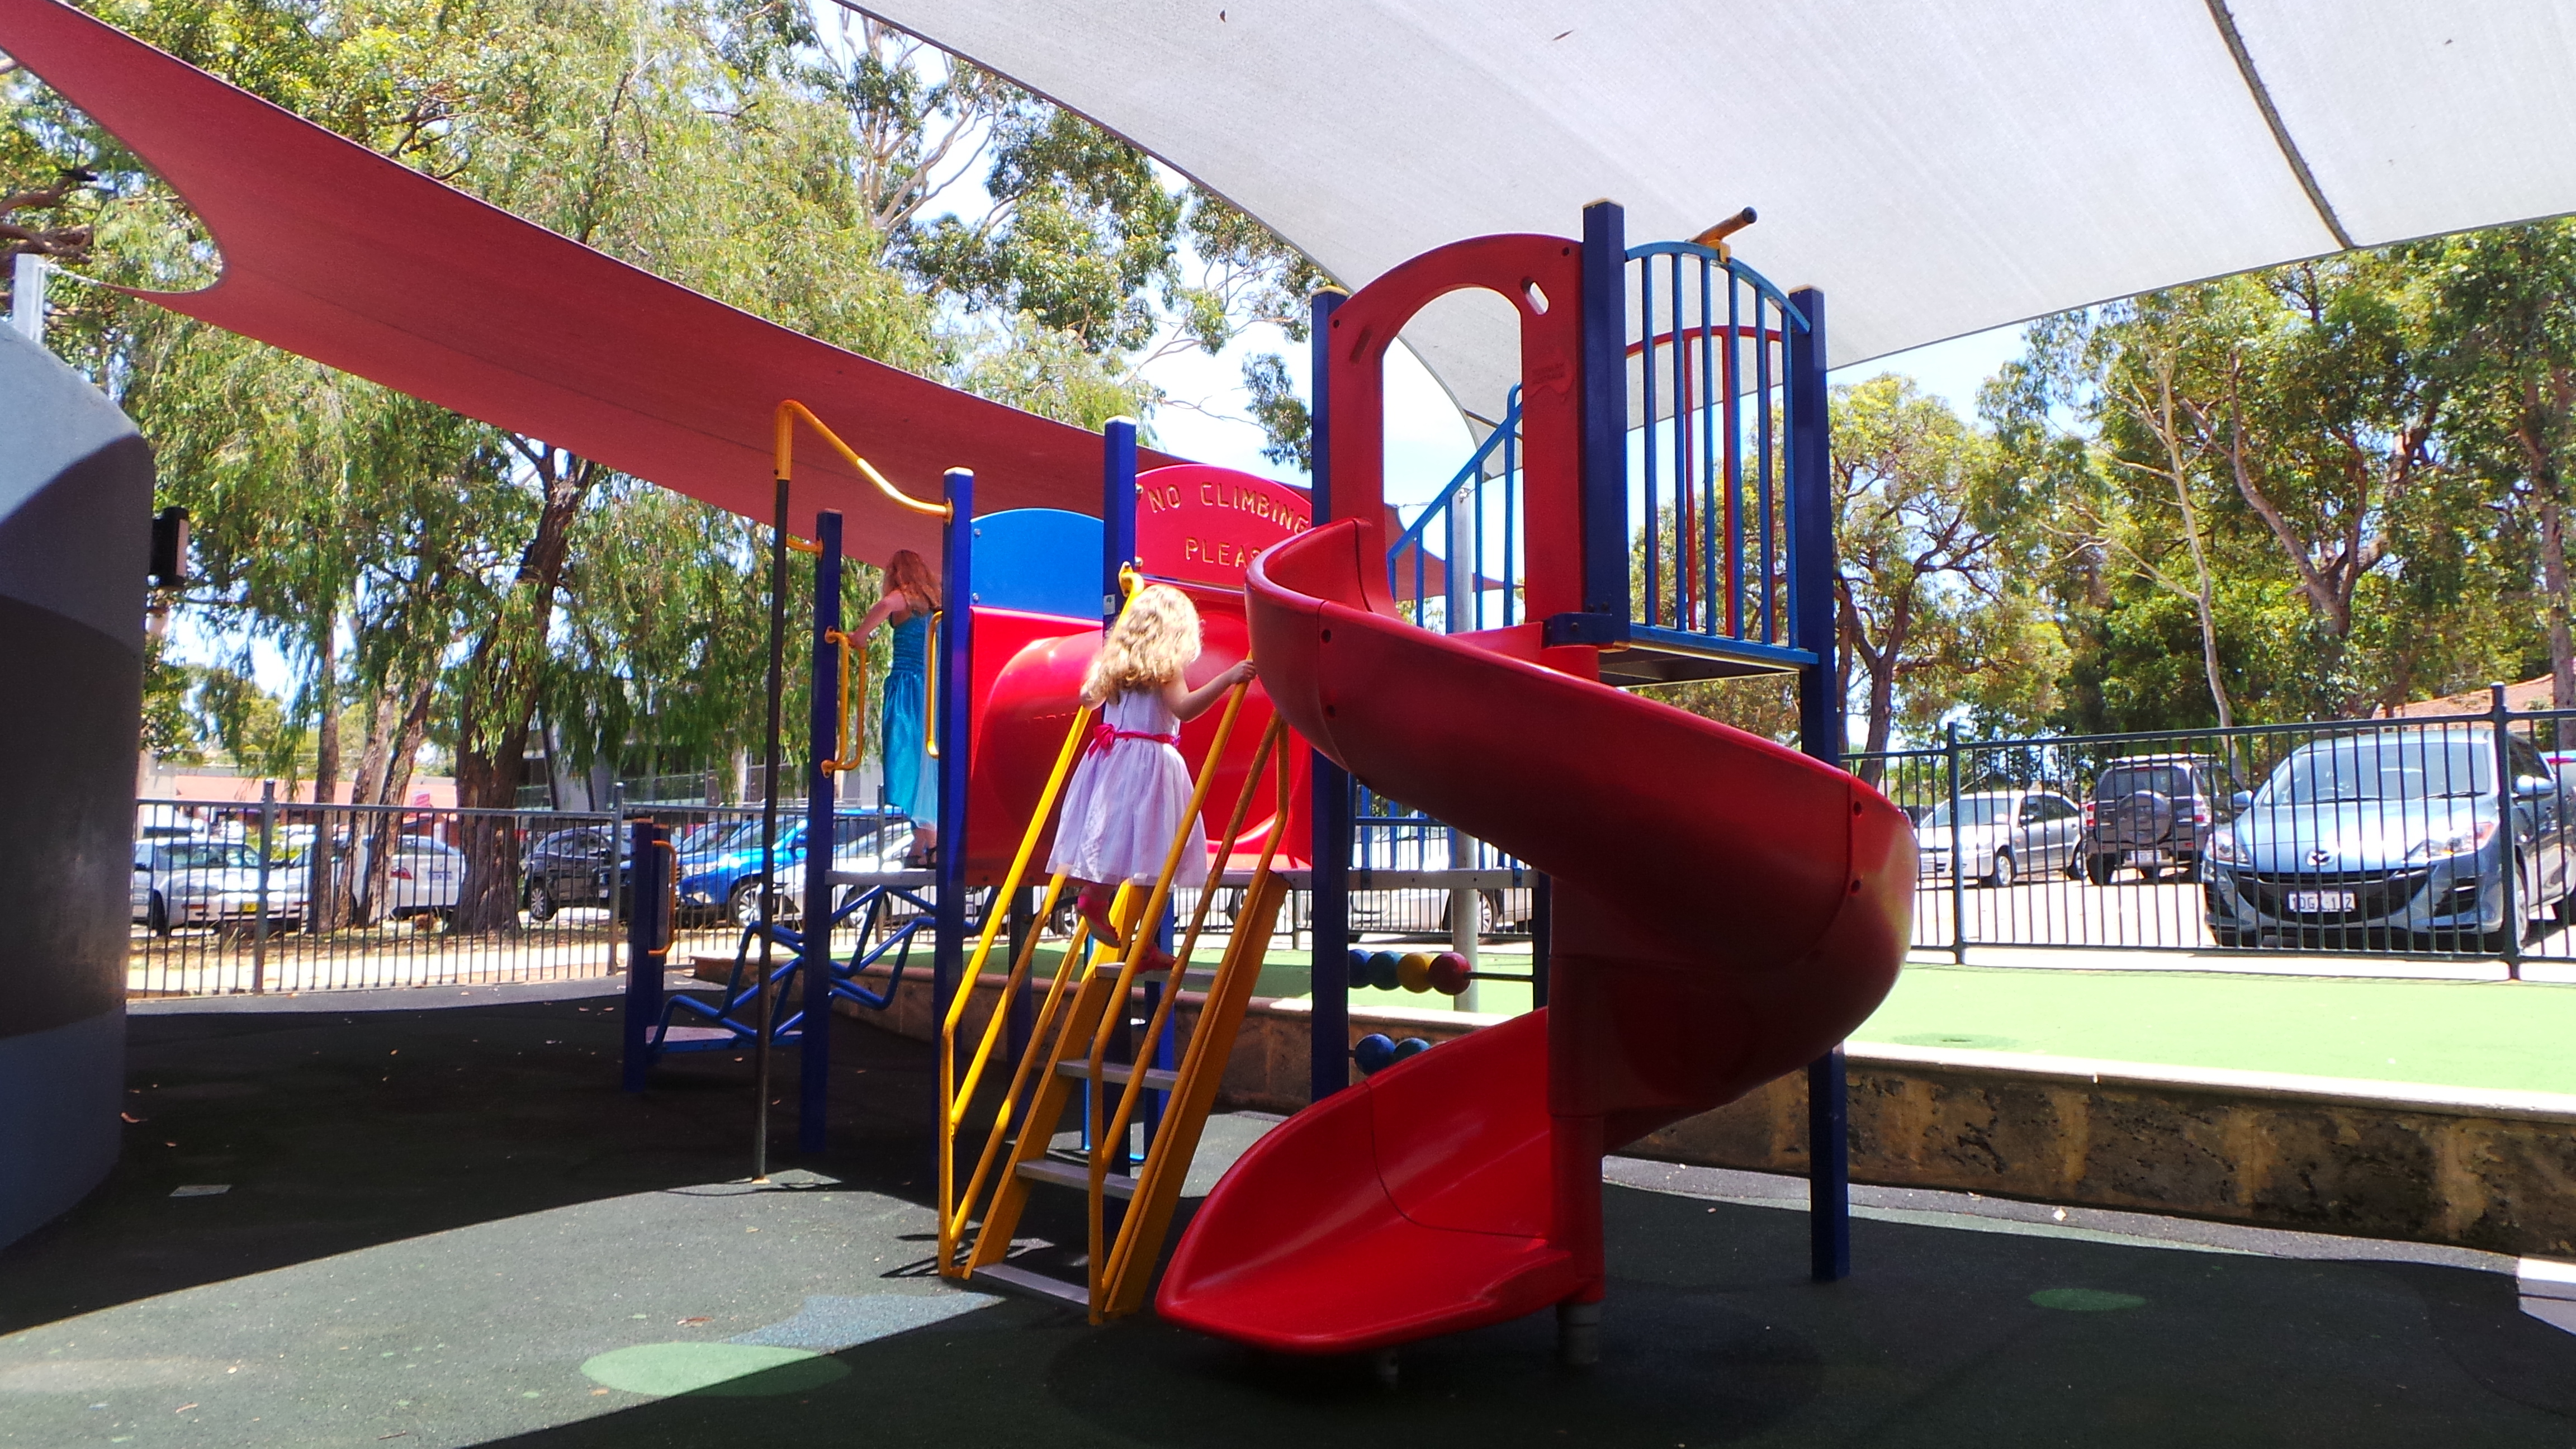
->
[0,987,2576,1449]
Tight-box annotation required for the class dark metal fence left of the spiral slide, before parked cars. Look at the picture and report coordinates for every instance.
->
[126,784,1528,995]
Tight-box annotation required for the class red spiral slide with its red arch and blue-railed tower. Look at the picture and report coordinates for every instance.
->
[1157,203,1914,1361]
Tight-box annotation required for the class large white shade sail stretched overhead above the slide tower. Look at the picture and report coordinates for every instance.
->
[860,0,2576,415]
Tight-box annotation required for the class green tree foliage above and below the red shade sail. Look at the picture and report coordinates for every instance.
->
[0,0,1314,835]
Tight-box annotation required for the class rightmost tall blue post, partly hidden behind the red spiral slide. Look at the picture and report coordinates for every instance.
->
[1788,286,1852,1284]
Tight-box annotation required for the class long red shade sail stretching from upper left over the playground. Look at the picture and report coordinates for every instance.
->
[0,0,1175,562]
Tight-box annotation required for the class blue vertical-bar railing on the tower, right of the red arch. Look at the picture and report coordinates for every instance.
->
[1628,243,1821,662]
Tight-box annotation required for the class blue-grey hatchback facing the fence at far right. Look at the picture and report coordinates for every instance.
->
[2203,724,2576,951]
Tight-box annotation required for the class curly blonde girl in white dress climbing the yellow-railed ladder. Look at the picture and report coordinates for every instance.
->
[1046,583,1252,949]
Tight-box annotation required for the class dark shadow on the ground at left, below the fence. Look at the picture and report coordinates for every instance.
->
[0,987,935,1333]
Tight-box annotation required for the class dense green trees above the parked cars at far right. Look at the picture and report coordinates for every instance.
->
[1983,236,2576,730]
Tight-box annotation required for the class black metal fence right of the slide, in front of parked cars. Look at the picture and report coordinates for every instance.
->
[1847,691,2576,969]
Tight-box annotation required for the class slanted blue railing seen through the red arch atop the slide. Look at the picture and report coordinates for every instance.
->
[1386,387,1522,634]
